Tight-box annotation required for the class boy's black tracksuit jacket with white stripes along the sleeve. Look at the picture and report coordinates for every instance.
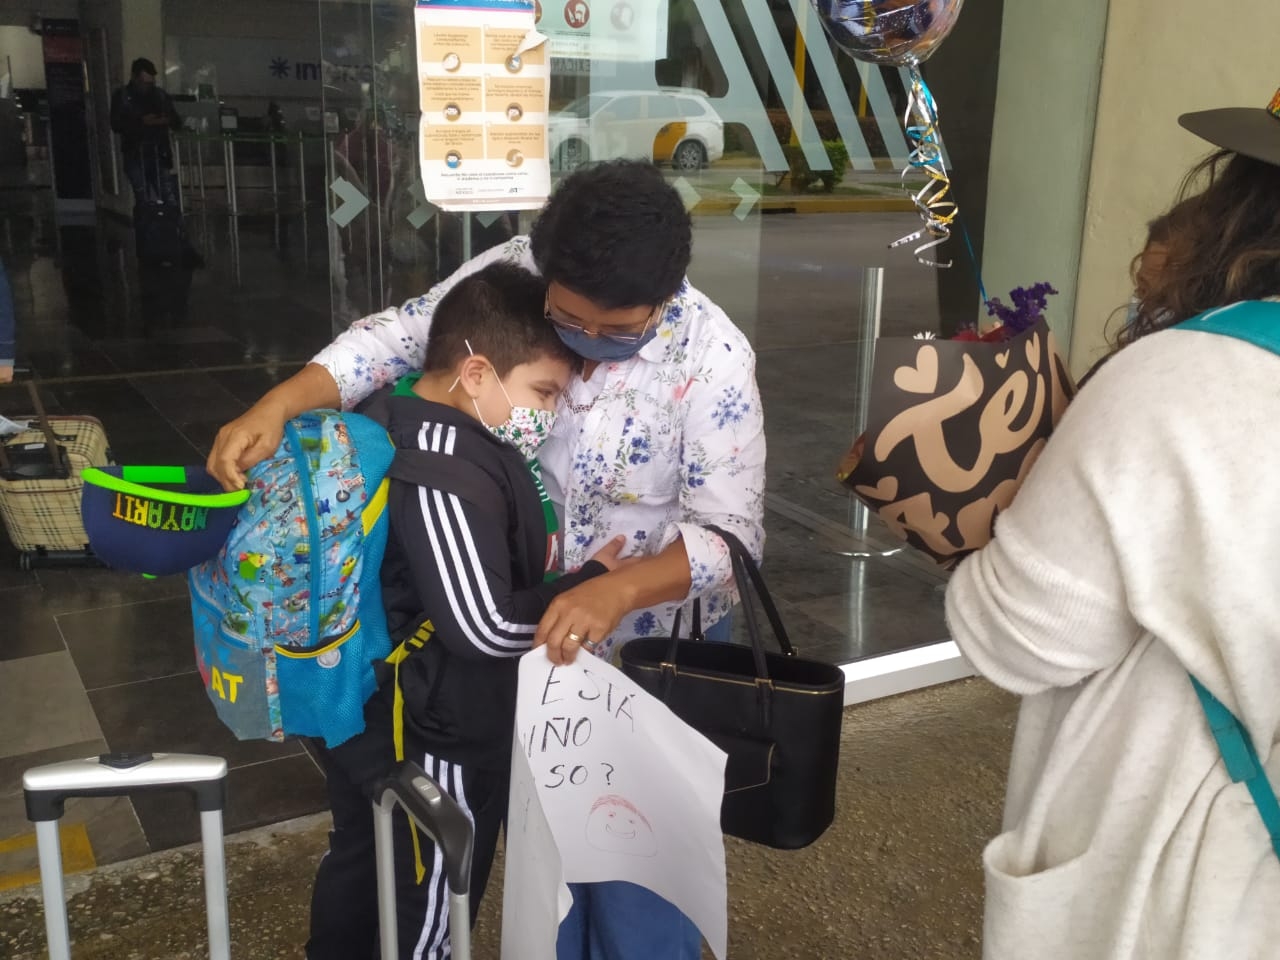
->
[375,396,605,772]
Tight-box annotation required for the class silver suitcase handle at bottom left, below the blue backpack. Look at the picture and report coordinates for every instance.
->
[22,754,230,960]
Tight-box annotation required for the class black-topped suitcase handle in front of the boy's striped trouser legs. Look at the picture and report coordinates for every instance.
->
[374,760,475,960]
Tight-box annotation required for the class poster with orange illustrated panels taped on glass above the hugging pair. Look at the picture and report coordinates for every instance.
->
[415,0,552,210]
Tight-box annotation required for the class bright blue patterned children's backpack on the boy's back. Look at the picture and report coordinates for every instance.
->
[189,410,396,746]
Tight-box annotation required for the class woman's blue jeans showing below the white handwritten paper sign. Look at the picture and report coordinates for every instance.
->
[556,881,703,960]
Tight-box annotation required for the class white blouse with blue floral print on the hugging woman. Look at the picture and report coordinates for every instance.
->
[312,237,764,657]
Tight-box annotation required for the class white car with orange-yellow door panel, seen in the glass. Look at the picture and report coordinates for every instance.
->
[549,87,724,170]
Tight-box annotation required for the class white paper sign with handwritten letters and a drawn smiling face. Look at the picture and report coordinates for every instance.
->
[502,648,728,960]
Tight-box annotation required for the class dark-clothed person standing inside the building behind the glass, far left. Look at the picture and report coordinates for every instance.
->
[111,58,182,205]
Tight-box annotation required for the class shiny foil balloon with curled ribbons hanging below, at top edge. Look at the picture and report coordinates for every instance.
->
[809,0,964,67]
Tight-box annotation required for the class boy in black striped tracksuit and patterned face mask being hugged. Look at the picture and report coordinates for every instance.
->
[300,264,622,960]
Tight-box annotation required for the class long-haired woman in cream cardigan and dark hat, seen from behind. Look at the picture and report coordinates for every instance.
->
[946,95,1280,960]
